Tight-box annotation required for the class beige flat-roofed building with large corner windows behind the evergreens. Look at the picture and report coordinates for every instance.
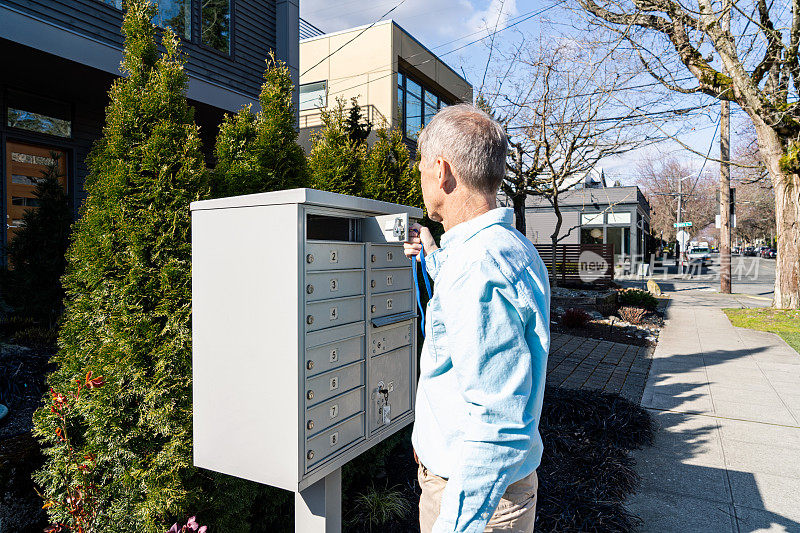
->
[300,20,472,150]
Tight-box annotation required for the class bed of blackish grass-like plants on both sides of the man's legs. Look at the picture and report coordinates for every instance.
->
[343,388,654,533]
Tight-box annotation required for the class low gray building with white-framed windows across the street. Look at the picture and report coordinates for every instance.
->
[525,178,653,261]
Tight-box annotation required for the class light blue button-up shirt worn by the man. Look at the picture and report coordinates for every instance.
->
[412,208,550,533]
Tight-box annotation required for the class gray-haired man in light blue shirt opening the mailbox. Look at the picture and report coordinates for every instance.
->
[405,105,550,533]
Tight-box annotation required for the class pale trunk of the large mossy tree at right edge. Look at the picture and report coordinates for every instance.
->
[751,121,800,309]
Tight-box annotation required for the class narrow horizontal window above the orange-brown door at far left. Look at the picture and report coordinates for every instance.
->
[6,91,72,138]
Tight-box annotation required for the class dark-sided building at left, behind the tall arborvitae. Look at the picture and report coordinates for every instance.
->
[0,0,299,256]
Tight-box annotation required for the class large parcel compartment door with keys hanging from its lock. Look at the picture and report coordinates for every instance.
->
[367,346,416,435]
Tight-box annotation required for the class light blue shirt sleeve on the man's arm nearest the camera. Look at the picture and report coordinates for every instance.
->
[433,256,541,533]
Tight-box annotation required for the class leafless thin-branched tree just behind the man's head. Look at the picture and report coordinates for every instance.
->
[479,37,660,246]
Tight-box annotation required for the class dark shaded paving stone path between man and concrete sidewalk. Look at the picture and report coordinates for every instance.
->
[547,333,652,403]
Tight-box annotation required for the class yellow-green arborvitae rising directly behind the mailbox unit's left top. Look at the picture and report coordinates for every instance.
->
[214,54,308,197]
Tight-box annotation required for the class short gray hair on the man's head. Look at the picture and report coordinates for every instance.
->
[419,104,508,194]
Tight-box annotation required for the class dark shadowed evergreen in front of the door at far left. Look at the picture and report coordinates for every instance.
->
[3,153,72,327]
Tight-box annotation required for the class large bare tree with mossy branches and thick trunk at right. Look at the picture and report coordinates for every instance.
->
[576,0,800,308]
